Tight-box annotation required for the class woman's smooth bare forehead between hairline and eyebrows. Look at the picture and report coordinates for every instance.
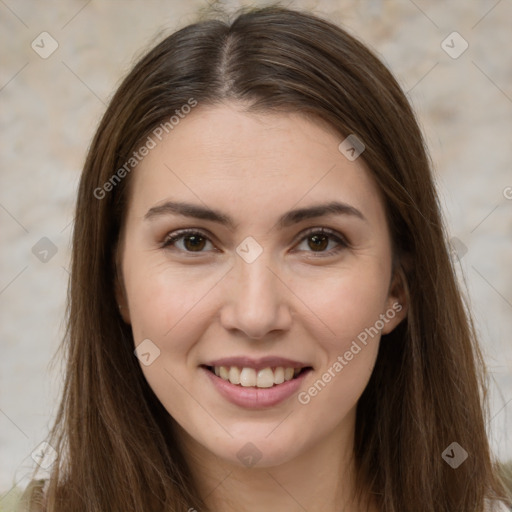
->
[129,104,383,225]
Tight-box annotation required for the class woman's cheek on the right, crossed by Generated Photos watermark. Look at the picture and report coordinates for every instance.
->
[295,264,389,404]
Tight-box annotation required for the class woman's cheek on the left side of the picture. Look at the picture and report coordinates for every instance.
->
[125,260,219,418]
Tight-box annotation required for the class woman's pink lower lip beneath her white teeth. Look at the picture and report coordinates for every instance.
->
[201,367,311,409]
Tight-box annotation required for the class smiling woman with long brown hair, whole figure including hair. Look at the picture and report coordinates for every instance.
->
[20,7,506,512]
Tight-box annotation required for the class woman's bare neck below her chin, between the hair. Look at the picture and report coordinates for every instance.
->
[176,410,376,512]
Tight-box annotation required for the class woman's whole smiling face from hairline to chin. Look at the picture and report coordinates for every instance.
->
[117,104,405,466]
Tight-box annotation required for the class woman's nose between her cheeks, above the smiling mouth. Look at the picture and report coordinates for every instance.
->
[220,255,292,340]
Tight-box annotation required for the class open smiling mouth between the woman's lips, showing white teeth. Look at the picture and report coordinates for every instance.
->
[201,365,313,389]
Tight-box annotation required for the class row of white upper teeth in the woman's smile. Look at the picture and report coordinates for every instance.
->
[213,366,301,388]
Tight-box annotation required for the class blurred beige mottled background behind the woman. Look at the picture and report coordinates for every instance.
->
[0,0,512,493]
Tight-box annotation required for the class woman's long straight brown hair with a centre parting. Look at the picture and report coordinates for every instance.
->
[21,6,504,512]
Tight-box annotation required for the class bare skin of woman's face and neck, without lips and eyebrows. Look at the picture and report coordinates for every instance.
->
[117,103,407,512]
